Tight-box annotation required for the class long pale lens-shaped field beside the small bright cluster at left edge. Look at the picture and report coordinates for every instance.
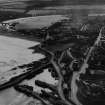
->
[3,15,69,30]
